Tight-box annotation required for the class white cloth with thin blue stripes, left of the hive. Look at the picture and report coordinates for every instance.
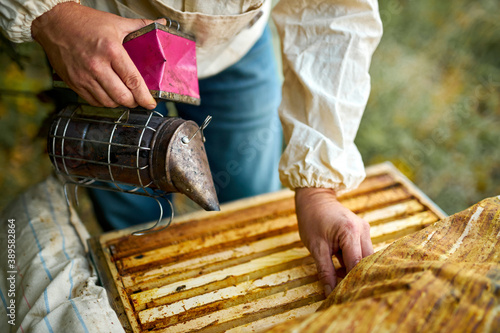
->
[0,177,124,333]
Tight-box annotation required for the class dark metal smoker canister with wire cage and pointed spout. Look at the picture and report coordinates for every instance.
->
[47,105,219,219]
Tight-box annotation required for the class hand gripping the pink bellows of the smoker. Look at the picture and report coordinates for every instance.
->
[31,2,160,109]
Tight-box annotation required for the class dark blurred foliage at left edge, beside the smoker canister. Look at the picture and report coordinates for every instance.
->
[0,37,53,209]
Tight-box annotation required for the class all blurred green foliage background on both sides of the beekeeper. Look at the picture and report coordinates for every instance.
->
[0,0,500,213]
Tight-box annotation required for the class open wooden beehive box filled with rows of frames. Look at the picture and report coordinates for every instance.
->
[89,163,445,332]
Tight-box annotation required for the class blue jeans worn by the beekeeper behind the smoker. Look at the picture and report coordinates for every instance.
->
[90,27,282,230]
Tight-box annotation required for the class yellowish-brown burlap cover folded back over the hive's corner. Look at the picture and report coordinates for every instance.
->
[272,197,500,332]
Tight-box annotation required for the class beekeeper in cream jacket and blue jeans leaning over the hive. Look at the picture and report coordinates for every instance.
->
[0,0,382,294]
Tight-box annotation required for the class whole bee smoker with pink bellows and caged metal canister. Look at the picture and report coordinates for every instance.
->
[47,20,219,235]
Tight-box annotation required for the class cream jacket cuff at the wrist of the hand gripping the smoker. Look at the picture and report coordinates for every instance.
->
[0,0,80,43]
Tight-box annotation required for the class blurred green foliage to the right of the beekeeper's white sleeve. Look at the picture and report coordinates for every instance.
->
[356,0,500,213]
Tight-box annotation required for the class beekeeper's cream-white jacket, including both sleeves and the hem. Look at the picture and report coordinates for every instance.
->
[0,0,382,192]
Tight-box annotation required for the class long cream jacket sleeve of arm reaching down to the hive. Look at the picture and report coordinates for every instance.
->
[273,0,382,193]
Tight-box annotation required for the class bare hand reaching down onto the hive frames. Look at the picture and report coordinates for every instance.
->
[295,188,373,296]
